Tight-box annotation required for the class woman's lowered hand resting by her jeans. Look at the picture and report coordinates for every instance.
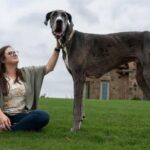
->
[0,110,11,131]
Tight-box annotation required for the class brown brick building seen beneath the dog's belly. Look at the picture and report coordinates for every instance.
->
[84,62,143,100]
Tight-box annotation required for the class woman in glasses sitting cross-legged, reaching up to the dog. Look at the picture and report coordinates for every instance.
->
[0,41,60,131]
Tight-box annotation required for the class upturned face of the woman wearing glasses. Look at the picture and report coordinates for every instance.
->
[4,47,19,65]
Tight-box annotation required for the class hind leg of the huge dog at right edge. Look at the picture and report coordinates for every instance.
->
[136,63,150,99]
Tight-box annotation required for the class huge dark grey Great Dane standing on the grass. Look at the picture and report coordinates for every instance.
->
[45,10,150,131]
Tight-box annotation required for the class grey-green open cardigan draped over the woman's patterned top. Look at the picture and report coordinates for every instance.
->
[0,66,45,111]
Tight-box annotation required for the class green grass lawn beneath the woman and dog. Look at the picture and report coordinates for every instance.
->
[0,99,150,150]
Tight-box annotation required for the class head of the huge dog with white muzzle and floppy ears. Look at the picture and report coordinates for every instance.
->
[44,10,73,39]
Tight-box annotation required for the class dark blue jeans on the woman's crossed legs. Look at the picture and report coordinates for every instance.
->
[8,110,49,131]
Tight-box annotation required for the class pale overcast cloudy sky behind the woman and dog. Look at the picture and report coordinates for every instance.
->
[0,0,150,98]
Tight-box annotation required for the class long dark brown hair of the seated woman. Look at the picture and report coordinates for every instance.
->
[0,45,24,96]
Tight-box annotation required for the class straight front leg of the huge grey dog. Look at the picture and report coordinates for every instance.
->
[71,79,84,131]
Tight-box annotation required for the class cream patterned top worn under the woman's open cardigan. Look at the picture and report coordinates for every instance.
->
[3,78,25,115]
